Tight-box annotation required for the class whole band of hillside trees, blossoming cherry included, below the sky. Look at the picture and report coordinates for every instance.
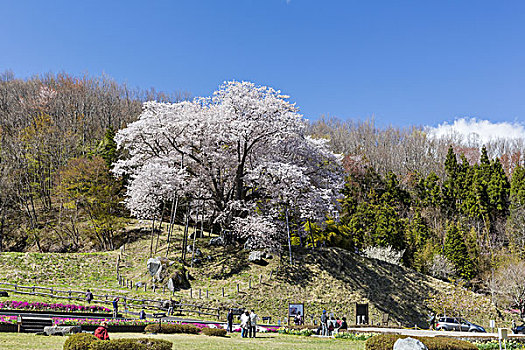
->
[0,72,525,309]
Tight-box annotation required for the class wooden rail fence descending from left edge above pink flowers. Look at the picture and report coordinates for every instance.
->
[0,282,220,319]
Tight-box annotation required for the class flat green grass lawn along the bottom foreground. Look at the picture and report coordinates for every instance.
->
[0,333,365,350]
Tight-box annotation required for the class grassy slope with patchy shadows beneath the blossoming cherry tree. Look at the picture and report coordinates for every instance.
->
[0,223,445,326]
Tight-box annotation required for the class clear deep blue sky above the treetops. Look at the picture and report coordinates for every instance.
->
[0,0,525,126]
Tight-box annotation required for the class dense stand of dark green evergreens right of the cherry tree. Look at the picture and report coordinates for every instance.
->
[319,143,525,288]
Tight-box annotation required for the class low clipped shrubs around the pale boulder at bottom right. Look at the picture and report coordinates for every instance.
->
[365,334,478,350]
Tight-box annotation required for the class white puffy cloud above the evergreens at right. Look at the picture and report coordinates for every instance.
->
[427,118,525,144]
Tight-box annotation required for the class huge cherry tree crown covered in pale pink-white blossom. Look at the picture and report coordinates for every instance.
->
[114,81,343,250]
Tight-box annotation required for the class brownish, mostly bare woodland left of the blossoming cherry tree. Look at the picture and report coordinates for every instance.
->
[0,72,187,251]
